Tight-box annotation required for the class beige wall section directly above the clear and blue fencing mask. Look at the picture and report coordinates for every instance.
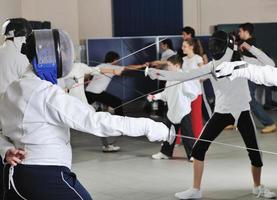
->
[22,0,79,45]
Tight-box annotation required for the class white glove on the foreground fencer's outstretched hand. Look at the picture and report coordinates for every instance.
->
[145,121,176,144]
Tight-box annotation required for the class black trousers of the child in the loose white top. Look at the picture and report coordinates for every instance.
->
[161,113,195,159]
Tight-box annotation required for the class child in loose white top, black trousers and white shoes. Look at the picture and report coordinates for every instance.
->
[148,55,198,160]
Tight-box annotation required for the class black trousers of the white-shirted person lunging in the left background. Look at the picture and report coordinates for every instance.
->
[86,91,123,116]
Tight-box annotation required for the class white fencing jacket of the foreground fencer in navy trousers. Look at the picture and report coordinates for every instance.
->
[0,69,169,168]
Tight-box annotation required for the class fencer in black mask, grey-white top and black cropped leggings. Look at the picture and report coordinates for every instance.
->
[144,31,276,199]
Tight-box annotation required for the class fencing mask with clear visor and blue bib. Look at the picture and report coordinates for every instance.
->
[22,29,74,84]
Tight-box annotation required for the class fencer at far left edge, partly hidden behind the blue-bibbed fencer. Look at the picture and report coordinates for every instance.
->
[0,18,32,199]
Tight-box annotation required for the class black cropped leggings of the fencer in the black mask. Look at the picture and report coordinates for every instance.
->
[192,111,263,167]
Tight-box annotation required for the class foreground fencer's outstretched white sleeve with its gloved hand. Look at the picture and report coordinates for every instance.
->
[45,88,169,141]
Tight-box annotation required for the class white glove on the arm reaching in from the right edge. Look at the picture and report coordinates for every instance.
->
[215,61,246,80]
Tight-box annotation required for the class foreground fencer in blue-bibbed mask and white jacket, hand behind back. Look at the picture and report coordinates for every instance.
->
[0,29,175,200]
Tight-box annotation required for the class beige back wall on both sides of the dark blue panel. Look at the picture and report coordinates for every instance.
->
[76,0,277,39]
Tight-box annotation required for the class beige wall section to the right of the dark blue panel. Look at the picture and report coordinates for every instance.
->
[183,0,277,35]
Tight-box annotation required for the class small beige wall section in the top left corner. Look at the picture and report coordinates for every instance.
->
[0,0,21,44]
